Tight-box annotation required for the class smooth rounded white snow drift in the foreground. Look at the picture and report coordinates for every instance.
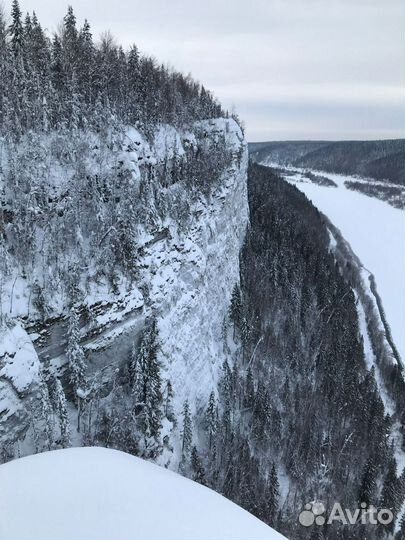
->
[0,448,283,540]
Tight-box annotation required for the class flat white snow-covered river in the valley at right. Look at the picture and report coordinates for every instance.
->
[280,171,405,360]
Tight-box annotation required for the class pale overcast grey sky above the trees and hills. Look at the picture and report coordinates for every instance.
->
[5,0,405,141]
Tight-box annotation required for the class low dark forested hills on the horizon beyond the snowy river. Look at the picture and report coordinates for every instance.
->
[249,139,405,184]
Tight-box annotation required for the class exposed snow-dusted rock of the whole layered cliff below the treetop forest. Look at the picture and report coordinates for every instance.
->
[0,119,248,462]
